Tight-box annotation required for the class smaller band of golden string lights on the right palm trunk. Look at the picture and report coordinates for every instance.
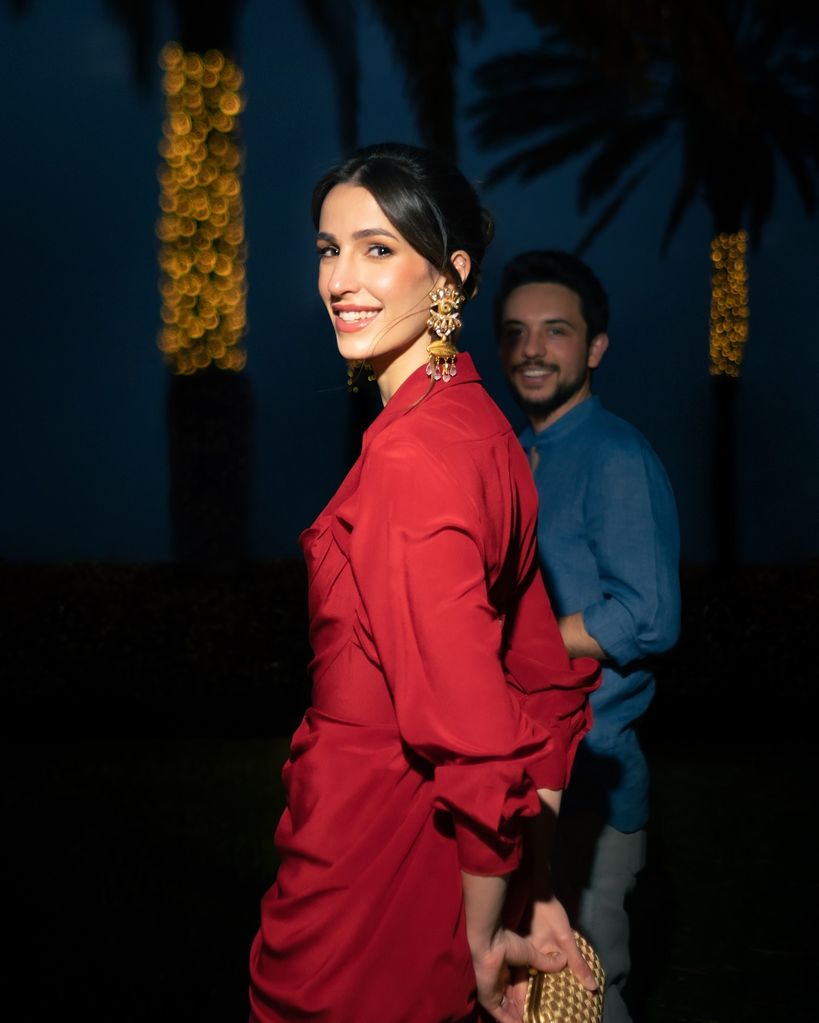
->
[709,230,748,376]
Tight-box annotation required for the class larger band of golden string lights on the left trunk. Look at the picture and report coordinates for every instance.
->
[156,43,247,373]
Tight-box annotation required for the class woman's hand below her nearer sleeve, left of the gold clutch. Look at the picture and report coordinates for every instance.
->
[472,928,564,1023]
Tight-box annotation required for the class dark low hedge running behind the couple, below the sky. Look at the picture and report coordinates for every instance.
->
[0,560,819,738]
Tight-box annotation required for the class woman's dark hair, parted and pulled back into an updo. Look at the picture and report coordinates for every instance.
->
[313,142,495,299]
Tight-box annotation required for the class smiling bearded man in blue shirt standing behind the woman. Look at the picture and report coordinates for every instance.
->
[496,252,680,1023]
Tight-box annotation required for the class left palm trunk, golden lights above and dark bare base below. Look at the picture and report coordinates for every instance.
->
[156,42,253,569]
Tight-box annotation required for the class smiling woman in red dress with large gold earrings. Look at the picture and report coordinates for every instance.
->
[251,143,597,1023]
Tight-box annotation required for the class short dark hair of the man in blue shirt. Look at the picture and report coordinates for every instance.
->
[495,249,608,342]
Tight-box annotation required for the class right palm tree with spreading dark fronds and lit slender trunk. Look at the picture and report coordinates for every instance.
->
[471,0,819,566]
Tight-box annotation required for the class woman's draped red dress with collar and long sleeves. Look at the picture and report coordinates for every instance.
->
[251,355,597,1023]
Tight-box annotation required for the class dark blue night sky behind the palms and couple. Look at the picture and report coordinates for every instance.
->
[0,0,819,562]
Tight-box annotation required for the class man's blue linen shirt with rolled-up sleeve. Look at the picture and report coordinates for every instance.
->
[520,396,680,832]
